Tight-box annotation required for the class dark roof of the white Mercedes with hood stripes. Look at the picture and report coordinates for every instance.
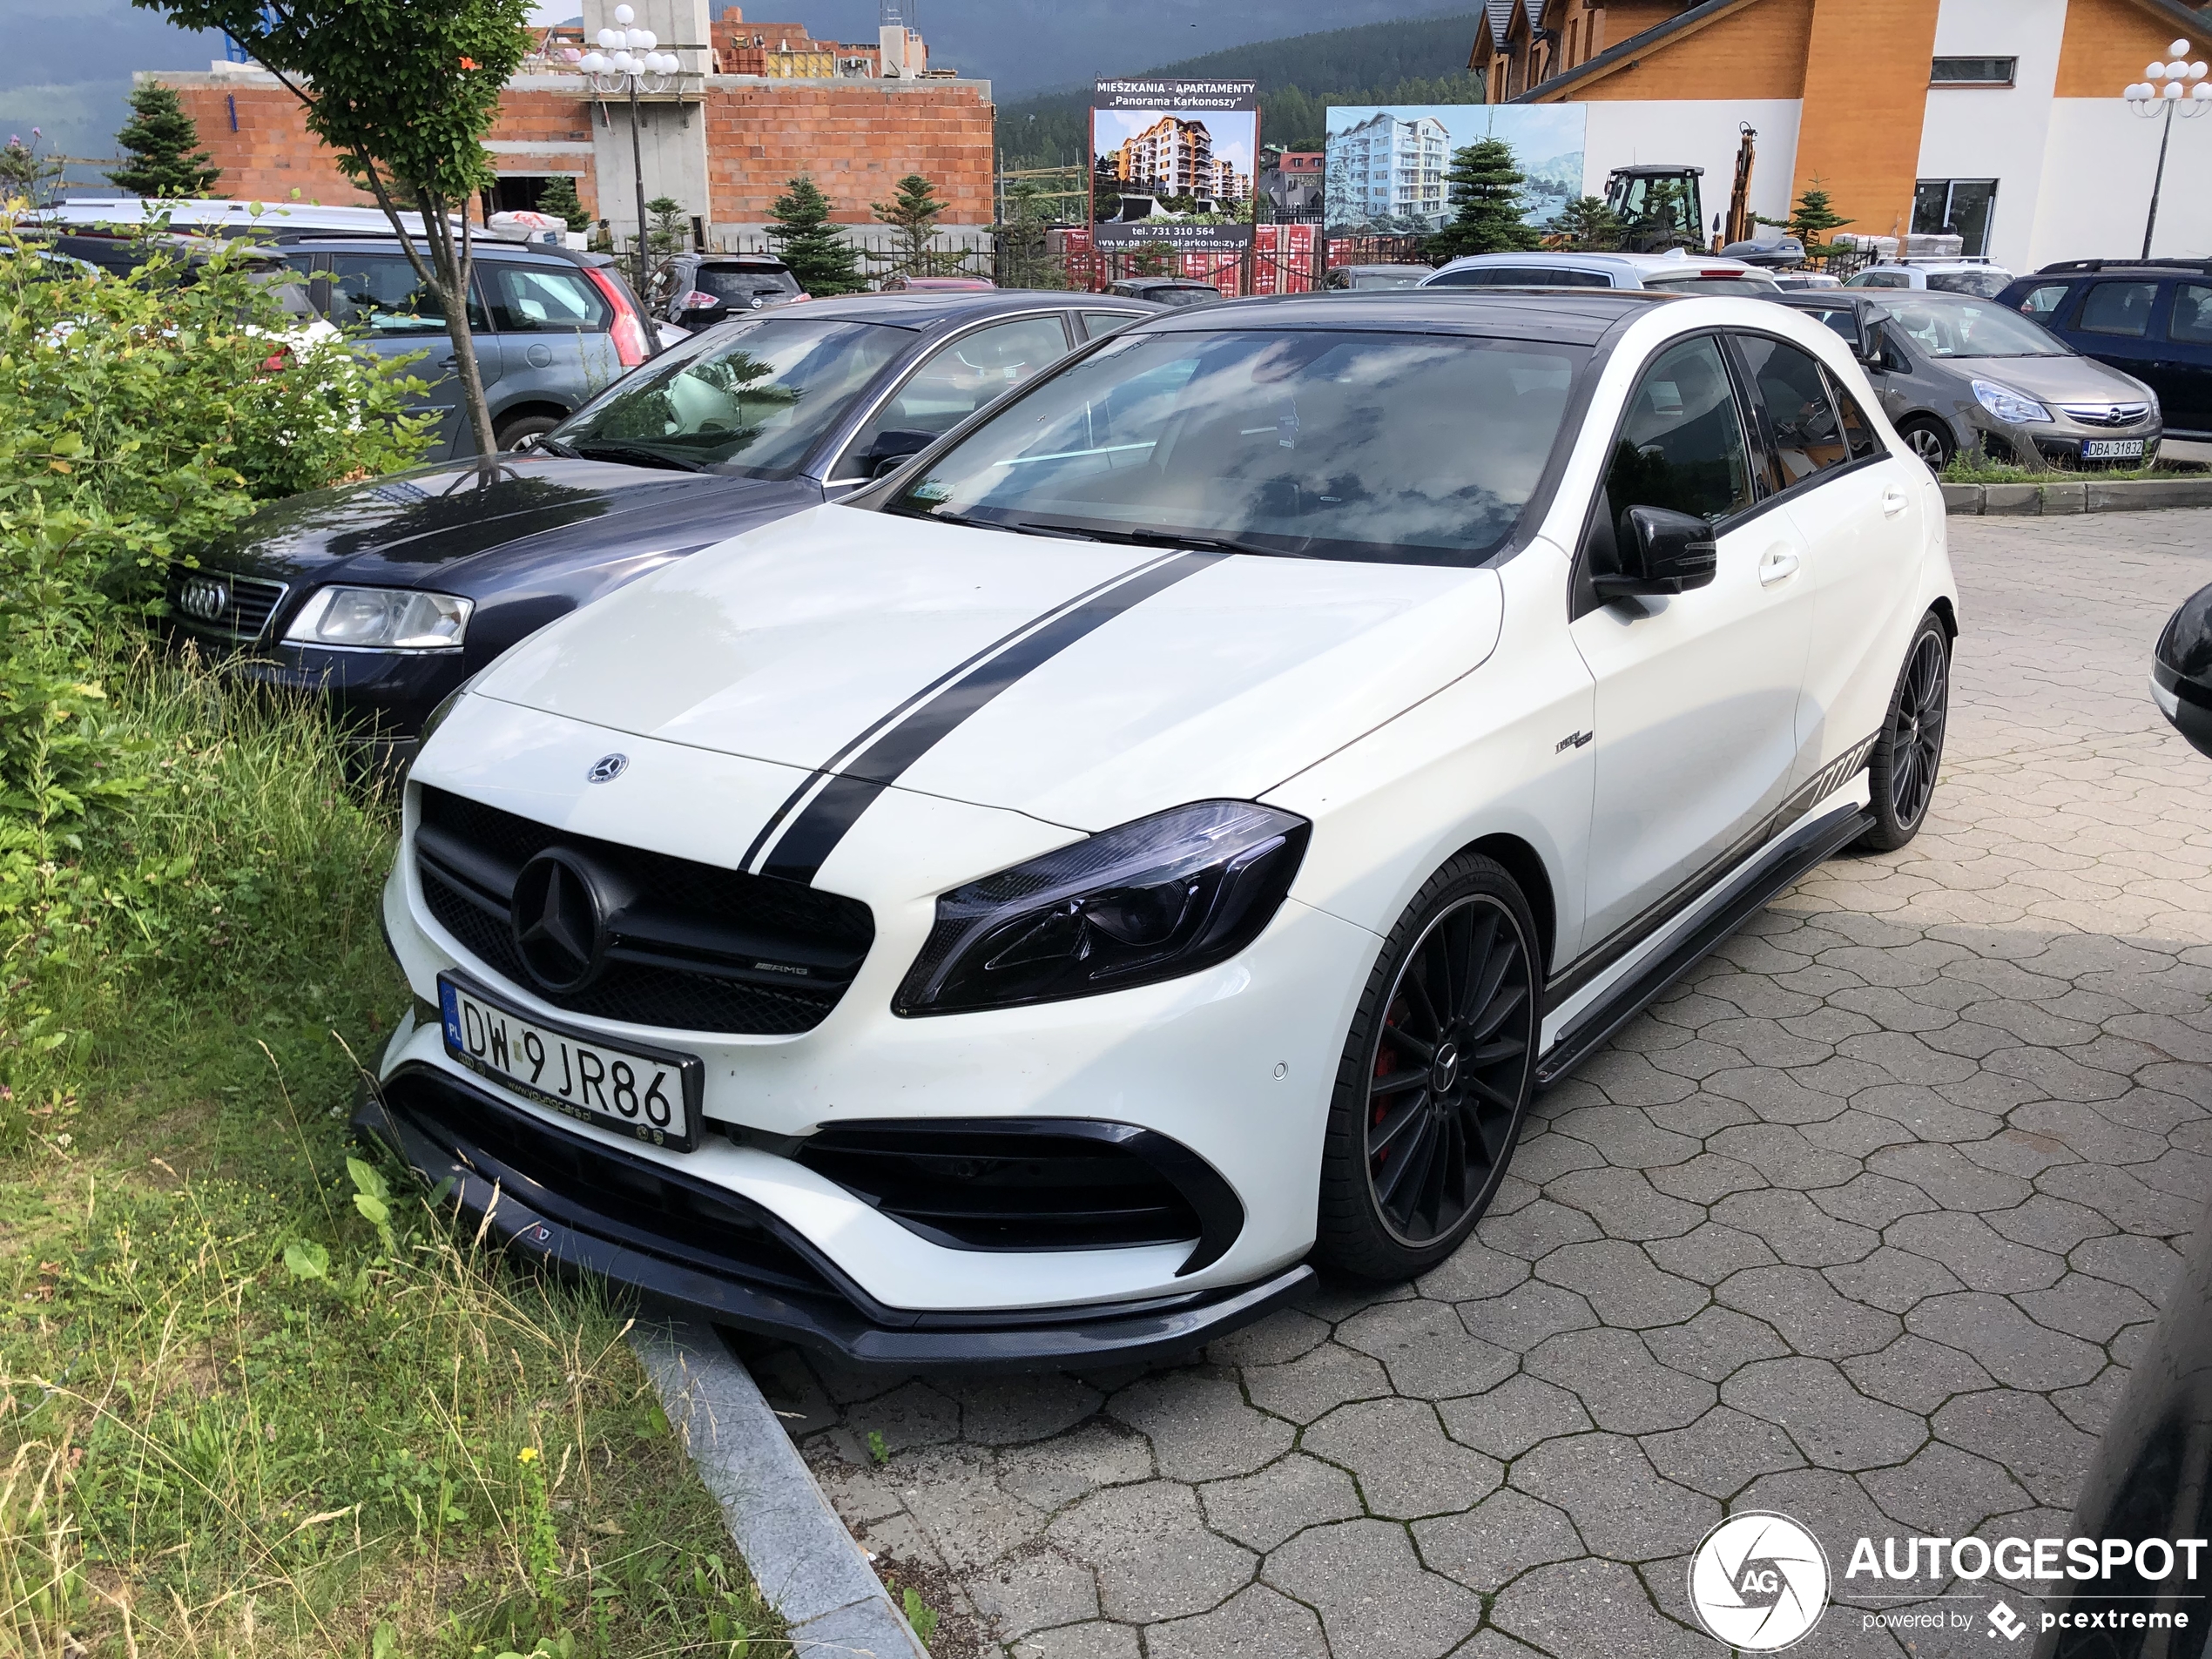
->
[1135,287,1683,345]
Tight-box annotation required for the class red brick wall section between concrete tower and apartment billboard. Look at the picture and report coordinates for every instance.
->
[705,79,993,226]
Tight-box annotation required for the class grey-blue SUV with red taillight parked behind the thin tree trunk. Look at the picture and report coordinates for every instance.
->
[277,233,652,460]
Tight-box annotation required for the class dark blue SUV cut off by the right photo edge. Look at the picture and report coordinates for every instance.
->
[1998,259,2212,442]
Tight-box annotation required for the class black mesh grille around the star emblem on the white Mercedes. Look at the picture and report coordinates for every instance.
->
[416,787,876,1037]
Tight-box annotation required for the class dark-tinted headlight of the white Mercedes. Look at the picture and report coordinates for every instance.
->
[892,800,1312,1015]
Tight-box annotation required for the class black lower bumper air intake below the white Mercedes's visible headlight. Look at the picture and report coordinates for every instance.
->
[794,1119,1243,1250]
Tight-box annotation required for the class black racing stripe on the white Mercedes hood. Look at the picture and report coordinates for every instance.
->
[741,553,1228,882]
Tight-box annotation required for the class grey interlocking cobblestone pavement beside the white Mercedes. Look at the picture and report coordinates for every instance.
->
[750,513,2212,1659]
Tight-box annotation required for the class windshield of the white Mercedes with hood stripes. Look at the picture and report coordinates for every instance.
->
[889,329,1588,564]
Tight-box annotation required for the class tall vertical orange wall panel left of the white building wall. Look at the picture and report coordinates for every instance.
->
[1790,0,1936,237]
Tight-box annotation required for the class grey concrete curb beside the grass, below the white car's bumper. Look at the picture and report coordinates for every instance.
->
[631,1320,929,1659]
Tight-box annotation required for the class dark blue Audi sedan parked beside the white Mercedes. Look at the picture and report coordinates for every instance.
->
[168,290,1162,761]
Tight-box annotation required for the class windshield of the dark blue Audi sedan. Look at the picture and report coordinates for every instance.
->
[549,316,914,478]
